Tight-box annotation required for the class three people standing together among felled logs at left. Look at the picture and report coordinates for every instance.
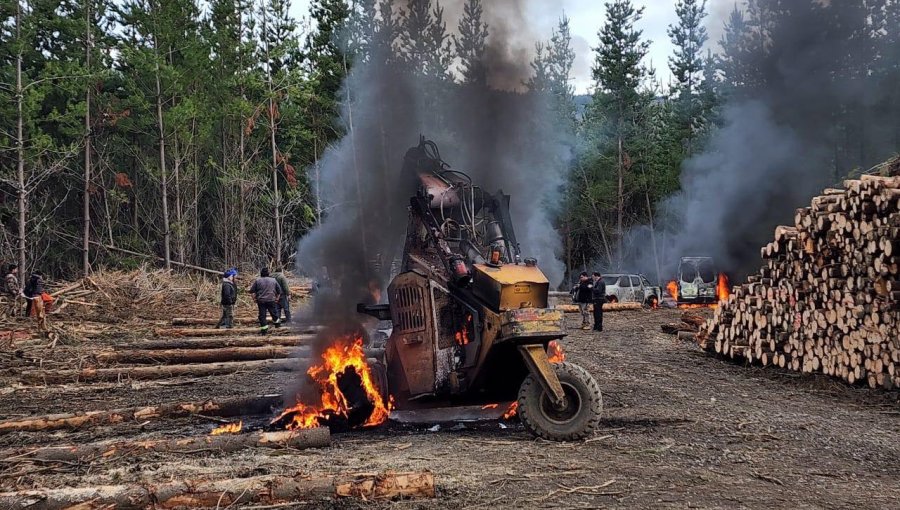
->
[216,267,291,335]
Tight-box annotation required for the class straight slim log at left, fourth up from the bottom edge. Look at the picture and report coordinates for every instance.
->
[20,358,302,384]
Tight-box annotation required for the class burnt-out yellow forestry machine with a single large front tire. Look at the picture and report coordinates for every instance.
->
[358,138,602,441]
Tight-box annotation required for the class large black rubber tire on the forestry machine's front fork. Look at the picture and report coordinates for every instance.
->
[519,363,603,441]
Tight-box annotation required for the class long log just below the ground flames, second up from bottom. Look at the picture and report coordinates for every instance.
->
[0,427,331,466]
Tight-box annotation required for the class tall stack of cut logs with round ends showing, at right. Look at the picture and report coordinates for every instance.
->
[697,175,900,388]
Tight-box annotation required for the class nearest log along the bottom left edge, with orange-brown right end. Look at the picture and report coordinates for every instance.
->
[0,471,435,510]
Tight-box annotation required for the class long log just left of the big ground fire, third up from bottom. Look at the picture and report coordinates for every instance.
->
[0,395,283,434]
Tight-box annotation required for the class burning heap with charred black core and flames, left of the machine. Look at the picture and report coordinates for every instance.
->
[272,336,393,430]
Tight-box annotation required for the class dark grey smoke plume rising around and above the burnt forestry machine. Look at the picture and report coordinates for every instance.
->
[297,0,566,336]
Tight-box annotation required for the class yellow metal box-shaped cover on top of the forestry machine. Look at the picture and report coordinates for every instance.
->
[472,264,550,311]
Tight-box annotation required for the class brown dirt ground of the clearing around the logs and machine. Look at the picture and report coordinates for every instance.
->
[0,304,900,509]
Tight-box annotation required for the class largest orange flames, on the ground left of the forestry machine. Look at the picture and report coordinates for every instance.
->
[273,337,394,430]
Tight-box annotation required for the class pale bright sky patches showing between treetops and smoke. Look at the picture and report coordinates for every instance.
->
[293,0,735,94]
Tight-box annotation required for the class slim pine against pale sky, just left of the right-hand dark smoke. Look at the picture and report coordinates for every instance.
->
[668,0,709,157]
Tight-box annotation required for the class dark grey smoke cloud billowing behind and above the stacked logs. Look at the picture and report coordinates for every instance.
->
[621,0,900,281]
